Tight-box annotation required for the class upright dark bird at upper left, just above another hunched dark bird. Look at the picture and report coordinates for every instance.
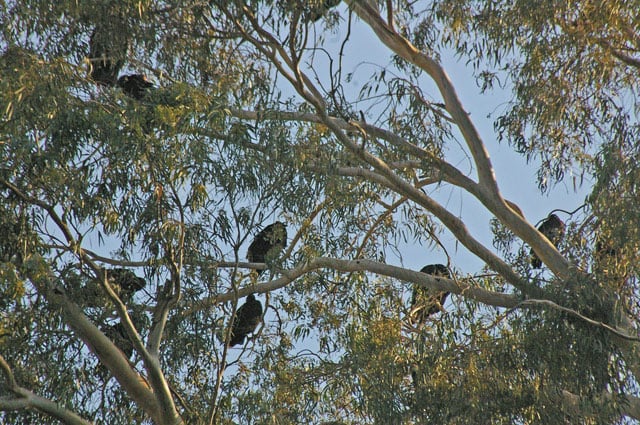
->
[89,27,127,86]
